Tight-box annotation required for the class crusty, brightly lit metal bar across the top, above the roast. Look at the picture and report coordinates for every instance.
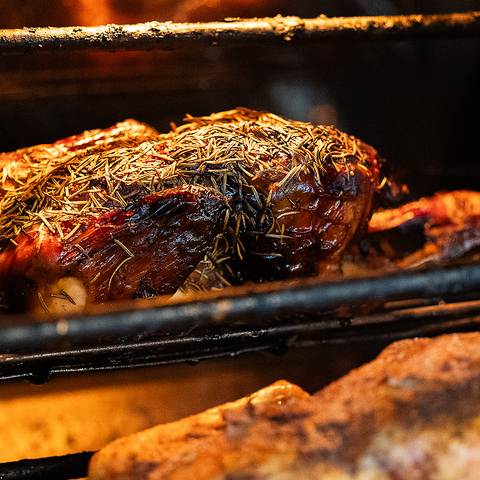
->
[0,11,480,55]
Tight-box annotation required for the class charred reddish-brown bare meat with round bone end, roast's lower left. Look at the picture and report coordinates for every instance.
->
[0,186,227,314]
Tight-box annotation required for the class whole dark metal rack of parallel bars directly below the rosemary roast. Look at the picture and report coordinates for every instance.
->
[0,264,480,384]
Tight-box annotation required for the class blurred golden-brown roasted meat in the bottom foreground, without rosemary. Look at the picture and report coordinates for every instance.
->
[88,333,480,480]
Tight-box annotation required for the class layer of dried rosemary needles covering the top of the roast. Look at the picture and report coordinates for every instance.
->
[0,108,369,283]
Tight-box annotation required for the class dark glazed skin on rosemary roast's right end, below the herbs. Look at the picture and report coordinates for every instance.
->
[240,165,376,282]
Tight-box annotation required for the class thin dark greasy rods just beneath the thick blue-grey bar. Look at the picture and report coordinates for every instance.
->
[0,301,480,384]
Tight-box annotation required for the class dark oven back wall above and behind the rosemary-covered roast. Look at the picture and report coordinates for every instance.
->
[0,0,480,195]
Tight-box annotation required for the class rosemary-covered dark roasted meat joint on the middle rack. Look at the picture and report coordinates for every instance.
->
[0,109,395,312]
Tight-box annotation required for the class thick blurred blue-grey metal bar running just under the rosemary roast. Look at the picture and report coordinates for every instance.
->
[0,263,480,358]
